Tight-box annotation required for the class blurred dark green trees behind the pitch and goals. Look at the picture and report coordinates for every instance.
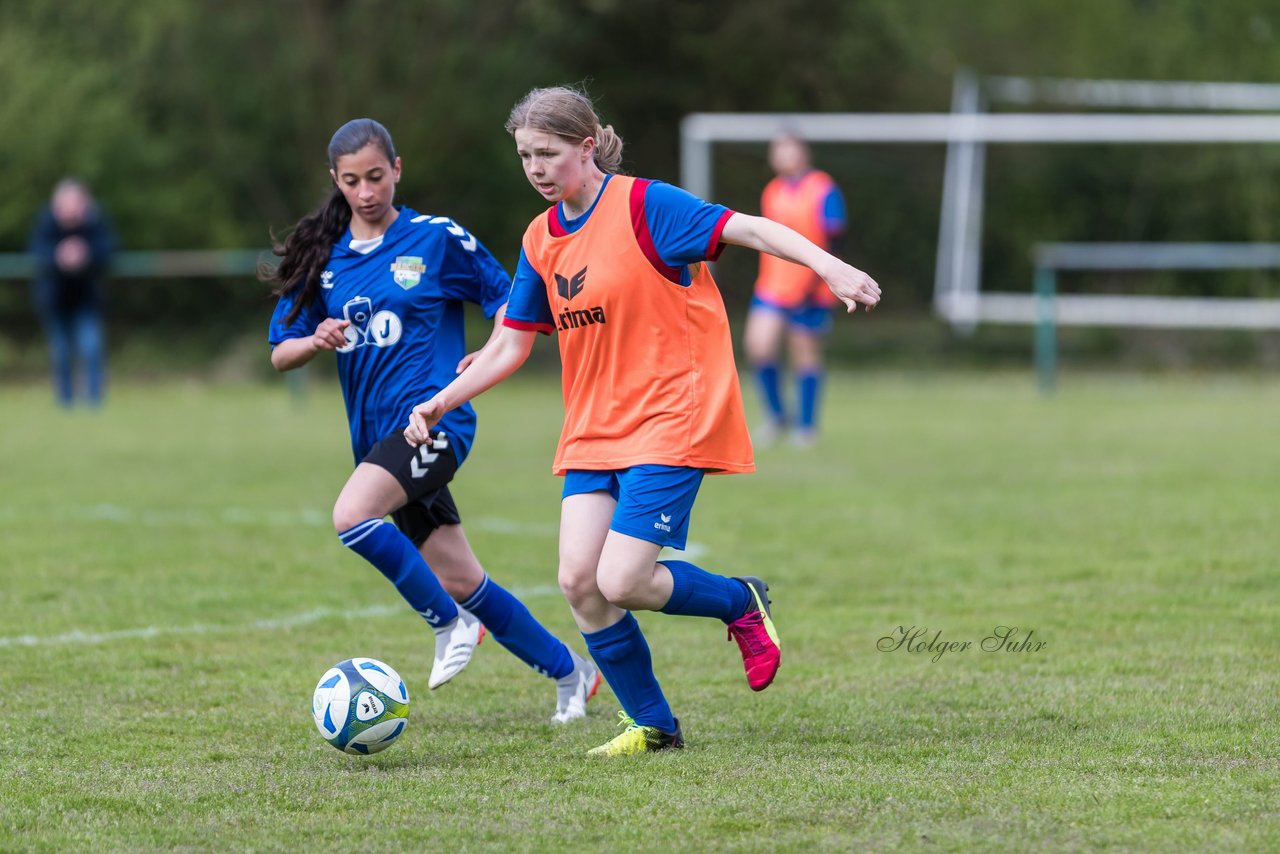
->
[0,0,1280,363]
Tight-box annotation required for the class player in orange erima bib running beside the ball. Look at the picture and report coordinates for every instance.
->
[404,87,879,757]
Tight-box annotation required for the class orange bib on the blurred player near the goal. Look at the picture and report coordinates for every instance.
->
[755,169,838,309]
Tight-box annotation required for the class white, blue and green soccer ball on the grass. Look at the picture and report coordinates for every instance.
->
[311,658,408,754]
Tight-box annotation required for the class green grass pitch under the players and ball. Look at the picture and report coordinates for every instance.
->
[0,375,1280,851]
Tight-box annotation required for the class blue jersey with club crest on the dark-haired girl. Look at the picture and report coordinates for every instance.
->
[268,207,511,462]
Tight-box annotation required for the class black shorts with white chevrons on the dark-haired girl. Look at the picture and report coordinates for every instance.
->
[364,430,462,547]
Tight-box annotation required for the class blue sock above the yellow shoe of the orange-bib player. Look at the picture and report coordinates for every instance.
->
[582,611,676,732]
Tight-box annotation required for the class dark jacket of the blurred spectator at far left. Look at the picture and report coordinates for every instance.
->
[28,205,115,314]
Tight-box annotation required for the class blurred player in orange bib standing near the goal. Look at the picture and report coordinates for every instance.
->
[745,133,845,447]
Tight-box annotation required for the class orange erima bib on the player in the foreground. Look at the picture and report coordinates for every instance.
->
[524,175,755,475]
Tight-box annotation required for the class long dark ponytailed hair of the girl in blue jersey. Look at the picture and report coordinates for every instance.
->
[259,119,396,325]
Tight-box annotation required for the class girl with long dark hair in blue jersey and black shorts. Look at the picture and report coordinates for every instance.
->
[269,119,600,722]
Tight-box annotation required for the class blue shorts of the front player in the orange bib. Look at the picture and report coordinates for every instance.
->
[562,466,703,549]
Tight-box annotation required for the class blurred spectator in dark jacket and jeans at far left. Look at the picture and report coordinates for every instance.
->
[29,178,115,407]
